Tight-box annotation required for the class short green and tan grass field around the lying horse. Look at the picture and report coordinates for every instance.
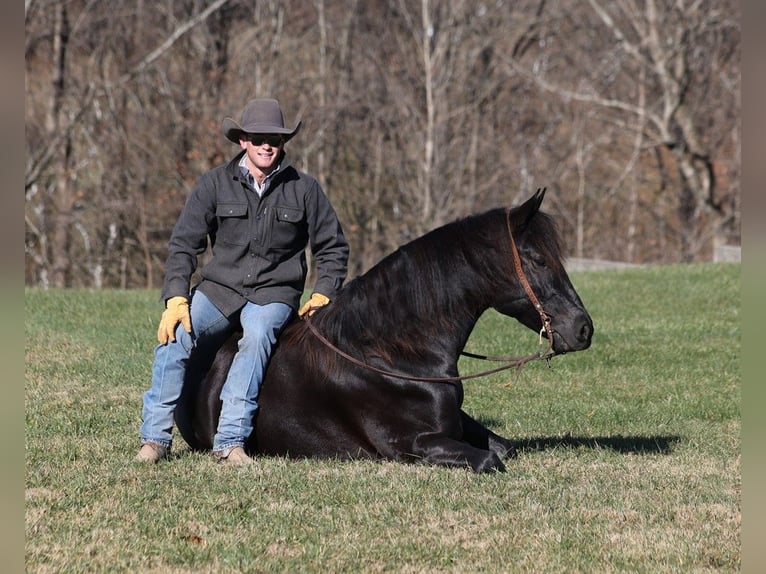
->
[25,264,741,573]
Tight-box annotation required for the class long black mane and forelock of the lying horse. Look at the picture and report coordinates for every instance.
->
[293,202,561,368]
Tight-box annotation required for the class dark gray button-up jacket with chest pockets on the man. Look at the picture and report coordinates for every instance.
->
[162,151,348,316]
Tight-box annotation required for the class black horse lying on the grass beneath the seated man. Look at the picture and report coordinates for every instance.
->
[176,191,593,472]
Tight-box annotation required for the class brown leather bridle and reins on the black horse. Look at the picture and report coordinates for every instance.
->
[303,196,555,383]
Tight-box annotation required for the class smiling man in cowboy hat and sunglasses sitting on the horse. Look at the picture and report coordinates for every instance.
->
[136,99,348,464]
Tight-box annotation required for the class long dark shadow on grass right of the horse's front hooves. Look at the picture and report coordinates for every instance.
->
[510,434,681,454]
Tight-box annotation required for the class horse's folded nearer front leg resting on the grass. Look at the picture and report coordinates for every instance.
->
[413,433,505,472]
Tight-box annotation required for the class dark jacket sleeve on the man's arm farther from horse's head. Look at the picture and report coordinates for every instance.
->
[162,176,216,301]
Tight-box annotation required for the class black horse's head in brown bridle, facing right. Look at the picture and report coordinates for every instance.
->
[492,189,593,354]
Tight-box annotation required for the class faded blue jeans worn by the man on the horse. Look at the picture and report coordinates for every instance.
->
[141,291,293,451]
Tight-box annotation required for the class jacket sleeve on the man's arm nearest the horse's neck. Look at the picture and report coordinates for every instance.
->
[306,180,349,299]
